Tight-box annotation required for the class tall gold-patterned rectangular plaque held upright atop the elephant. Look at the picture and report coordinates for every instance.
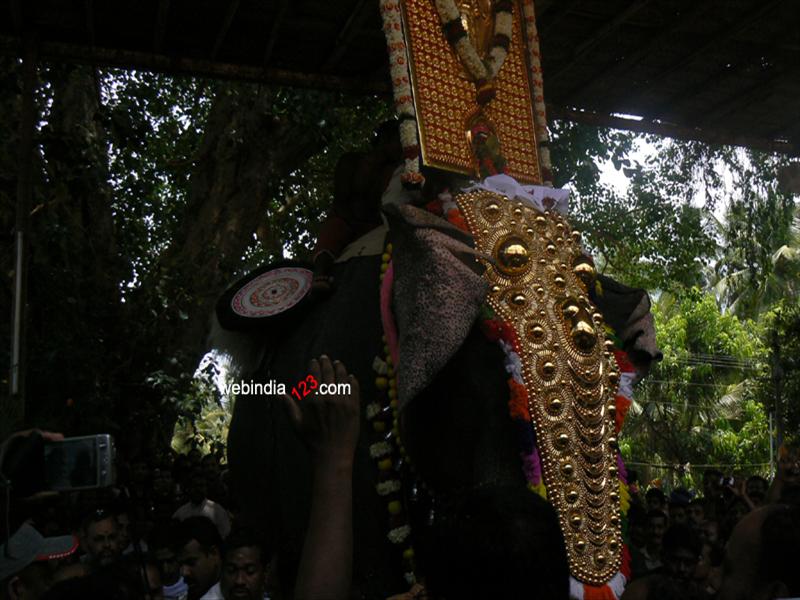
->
[402,0,541,183]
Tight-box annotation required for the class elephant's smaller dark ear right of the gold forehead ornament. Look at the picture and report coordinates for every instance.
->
[592,275,664,379]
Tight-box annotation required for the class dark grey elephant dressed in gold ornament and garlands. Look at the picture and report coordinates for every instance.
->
[217,200,658,598]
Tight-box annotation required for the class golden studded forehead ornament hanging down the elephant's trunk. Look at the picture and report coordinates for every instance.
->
[455,190,622,585]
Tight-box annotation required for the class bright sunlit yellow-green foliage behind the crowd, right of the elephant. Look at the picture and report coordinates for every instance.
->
[623,288,769,488]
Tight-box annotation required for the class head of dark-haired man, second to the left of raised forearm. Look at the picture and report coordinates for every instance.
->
[175,517,222,600]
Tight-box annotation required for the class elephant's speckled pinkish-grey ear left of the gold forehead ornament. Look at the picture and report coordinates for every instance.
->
[384,204,490,410]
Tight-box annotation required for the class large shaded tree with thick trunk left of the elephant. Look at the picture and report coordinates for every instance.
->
[0,63,387,452]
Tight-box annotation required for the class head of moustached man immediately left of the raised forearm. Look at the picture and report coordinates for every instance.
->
[220,531,269,600]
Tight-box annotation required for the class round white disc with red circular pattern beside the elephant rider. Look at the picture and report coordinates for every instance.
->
[231,267,313,319]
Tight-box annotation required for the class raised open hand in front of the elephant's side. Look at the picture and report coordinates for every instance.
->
[284,355,361,461]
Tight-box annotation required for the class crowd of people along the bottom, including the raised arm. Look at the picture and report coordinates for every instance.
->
[0,357,800,600]
